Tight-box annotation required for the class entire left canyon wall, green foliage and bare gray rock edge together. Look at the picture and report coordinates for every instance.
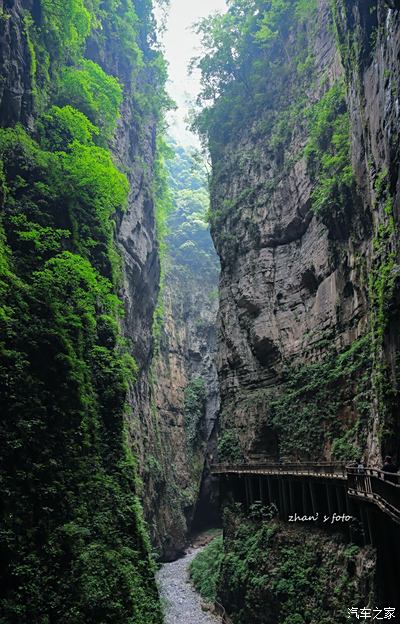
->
[0,0,165,624]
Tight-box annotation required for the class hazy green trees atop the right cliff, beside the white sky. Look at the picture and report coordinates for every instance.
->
[192,0,316,153]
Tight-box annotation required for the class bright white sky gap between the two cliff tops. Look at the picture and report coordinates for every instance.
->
[159,0,227,147]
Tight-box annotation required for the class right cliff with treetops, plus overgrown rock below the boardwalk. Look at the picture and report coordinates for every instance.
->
[188,0,400,624]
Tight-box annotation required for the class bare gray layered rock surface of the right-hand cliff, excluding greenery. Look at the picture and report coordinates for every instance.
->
[212,0,400,463]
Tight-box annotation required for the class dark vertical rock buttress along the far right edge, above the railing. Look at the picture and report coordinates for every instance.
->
[335,2,400,462]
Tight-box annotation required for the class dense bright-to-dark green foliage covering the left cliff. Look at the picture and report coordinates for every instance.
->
[0,0,165,624]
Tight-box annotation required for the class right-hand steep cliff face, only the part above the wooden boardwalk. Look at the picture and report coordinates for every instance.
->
[199,0,399,462]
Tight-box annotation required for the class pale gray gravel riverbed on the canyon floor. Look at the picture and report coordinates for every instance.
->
[157,548,221,624]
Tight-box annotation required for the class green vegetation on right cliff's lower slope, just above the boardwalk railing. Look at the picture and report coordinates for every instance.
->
[218,334,374,463]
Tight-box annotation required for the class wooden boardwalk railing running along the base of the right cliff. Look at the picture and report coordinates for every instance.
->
[211,462,400,523]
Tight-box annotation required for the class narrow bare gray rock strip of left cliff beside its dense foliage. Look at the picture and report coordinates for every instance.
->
[87,3,164,548]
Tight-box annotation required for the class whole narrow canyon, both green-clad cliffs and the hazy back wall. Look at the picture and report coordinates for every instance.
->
[0,0,400,624]
